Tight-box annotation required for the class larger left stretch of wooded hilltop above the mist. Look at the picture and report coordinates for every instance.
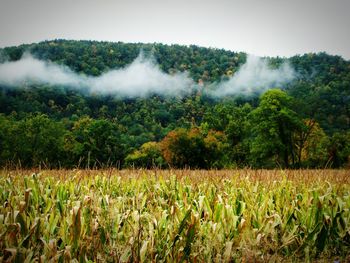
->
[3,40,246,81]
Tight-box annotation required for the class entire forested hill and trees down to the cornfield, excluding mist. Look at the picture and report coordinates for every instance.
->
[0,40,350,168]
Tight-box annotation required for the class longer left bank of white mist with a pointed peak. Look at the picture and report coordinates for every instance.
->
[0,54,195,97]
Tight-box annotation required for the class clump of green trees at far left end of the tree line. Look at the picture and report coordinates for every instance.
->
[0,114,66,168]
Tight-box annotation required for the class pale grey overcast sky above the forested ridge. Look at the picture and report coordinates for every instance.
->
[0,0,350,59]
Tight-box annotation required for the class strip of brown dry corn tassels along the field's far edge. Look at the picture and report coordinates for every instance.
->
[0,169,350,184]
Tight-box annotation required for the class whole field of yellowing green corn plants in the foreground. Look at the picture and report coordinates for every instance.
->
[0,170,350,262]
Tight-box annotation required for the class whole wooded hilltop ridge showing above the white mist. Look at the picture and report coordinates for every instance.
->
[0,40,350,82]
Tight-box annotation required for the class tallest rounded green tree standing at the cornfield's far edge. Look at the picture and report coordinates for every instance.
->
[251,89,303,168]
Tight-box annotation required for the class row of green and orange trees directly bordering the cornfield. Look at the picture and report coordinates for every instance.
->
[0,89,350,169]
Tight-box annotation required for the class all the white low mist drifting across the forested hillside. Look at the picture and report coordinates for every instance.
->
[0,53,296,97]
